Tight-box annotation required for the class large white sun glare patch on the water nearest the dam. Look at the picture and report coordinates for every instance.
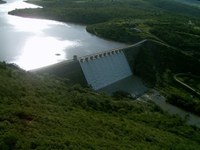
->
[15,37,77,70]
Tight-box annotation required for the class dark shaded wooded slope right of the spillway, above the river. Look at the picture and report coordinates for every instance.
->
[129,41,200,115]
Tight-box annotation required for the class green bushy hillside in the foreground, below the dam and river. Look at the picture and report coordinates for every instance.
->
[0,63,200,150]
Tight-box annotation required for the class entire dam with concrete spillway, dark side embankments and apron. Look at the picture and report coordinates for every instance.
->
[32,40,146,96]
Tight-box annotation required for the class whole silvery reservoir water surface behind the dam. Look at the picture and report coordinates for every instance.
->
[0,0,126,70]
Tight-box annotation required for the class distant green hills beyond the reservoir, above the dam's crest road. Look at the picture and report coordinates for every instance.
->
[9,0,200,59]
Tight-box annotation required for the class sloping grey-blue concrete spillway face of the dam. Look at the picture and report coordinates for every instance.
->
[79,51,132,90]
